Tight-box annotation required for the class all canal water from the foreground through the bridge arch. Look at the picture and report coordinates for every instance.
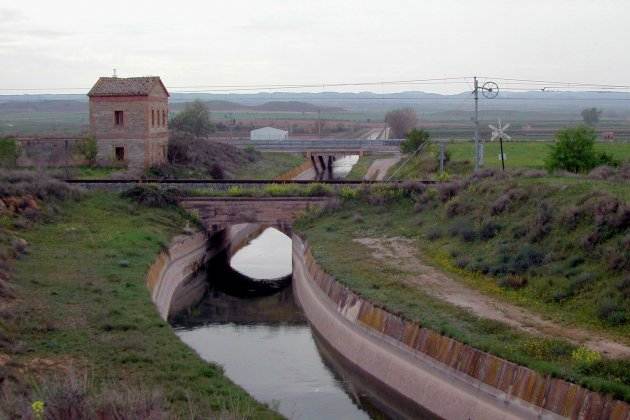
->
[172,228,385,419]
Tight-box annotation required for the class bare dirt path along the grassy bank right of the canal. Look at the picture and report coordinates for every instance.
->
[354,237,630,358]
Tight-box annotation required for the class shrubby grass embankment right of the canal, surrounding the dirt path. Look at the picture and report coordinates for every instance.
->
[295,173,630,401]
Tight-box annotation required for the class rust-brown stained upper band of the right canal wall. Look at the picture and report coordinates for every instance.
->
[293,235,630,420]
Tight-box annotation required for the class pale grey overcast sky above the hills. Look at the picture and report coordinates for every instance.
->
[0,0,630,93]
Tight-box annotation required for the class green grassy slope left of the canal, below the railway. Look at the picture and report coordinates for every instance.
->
[0,189,276,418]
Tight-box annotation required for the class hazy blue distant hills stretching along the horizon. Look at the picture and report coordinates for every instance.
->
[0,90,630,120]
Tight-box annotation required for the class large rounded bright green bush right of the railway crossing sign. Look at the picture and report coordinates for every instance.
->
[545,126,615,173]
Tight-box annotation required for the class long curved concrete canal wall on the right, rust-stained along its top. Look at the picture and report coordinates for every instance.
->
[293,234,630,420]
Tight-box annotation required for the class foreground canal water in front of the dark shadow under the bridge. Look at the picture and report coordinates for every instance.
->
[173,287,369,419]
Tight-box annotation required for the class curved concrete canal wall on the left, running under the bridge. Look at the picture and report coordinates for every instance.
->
[146,224,261,320]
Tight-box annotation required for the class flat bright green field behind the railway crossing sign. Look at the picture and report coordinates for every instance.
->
[389,141,630,179]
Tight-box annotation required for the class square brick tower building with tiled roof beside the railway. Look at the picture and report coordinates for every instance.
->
[88,77,169,171]
